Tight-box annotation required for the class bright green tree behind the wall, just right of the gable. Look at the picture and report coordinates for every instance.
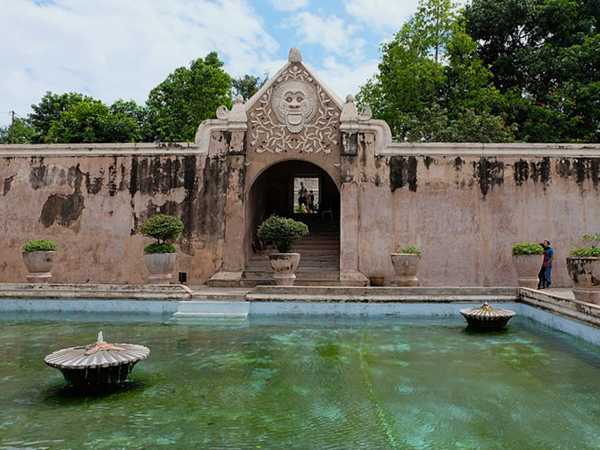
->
[358,0,513,142]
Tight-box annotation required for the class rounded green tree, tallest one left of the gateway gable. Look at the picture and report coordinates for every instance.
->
[147,52,231,141]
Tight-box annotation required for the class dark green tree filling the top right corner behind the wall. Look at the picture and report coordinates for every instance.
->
[465,0,600,142]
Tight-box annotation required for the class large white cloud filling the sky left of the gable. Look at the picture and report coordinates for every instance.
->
[0,0,279,124]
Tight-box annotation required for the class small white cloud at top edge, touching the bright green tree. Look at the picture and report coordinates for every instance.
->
[346,0,418,32]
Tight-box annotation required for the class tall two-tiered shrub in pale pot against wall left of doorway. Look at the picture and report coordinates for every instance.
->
[140,214,183,282]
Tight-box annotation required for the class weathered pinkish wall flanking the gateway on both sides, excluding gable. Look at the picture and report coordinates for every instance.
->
[0,142,600,286]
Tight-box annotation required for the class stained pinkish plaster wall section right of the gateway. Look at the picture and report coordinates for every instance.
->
[345,144,600,286]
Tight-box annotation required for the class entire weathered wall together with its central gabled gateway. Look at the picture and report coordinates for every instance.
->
[0,50,600,286]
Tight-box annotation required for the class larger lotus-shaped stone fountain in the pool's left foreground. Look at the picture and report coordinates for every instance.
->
[44,331,150,389]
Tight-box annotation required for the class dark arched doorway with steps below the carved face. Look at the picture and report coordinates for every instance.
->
[242,160,340,285]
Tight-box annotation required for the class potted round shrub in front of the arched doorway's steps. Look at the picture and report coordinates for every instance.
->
[257,215,308,286]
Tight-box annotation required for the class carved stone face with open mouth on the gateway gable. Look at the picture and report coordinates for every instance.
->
[272,80,317,133]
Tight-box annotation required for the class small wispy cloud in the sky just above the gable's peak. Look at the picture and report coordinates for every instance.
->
[289,12,365,59]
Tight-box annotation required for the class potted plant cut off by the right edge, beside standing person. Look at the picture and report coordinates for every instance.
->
[567,233,600,305]
